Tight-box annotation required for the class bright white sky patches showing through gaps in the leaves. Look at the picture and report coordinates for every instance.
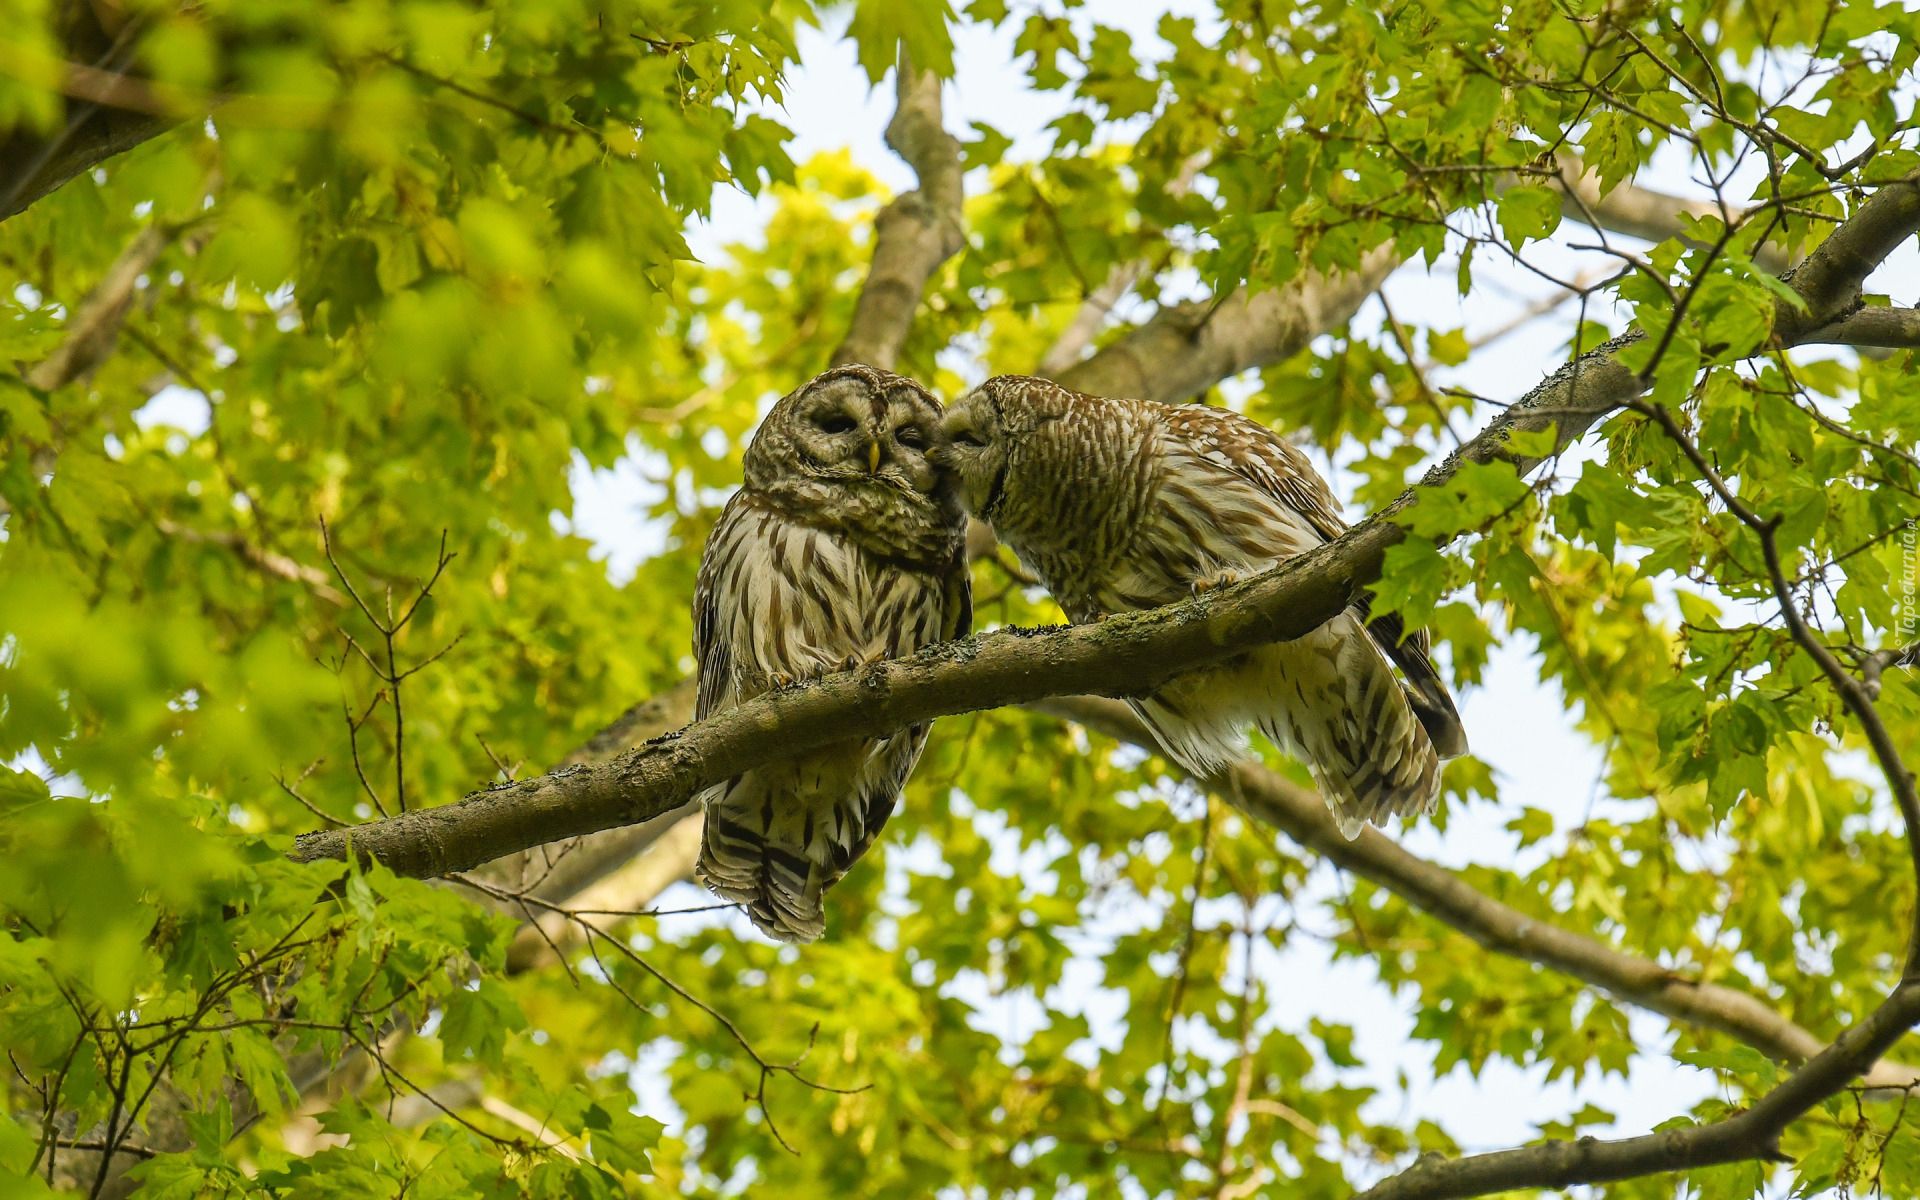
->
[116,0,1920,1175]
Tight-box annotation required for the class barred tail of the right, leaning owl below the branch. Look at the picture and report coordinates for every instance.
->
[1261,616,1459,841]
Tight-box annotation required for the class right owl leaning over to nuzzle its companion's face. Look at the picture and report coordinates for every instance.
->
[939,374,1467,837]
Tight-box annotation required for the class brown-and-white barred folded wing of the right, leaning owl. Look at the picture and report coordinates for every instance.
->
[1167,405,1467,758]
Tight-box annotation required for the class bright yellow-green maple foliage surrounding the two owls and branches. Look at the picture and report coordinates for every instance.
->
[0,0,1920,1200]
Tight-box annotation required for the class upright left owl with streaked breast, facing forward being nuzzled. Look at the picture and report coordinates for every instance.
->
[693,365,973,941]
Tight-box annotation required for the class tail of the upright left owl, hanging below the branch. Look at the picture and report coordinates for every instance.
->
[693,758,899,943]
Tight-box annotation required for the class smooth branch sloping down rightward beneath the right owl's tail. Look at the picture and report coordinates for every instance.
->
[1029,697,1920,1089]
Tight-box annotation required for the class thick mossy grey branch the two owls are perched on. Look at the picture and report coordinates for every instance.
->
[294,166,1920,898]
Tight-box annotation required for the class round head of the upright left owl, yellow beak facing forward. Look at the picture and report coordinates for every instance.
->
[743,363,966,561]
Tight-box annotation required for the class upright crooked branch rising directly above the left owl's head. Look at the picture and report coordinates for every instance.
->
[831,54,966,371]
